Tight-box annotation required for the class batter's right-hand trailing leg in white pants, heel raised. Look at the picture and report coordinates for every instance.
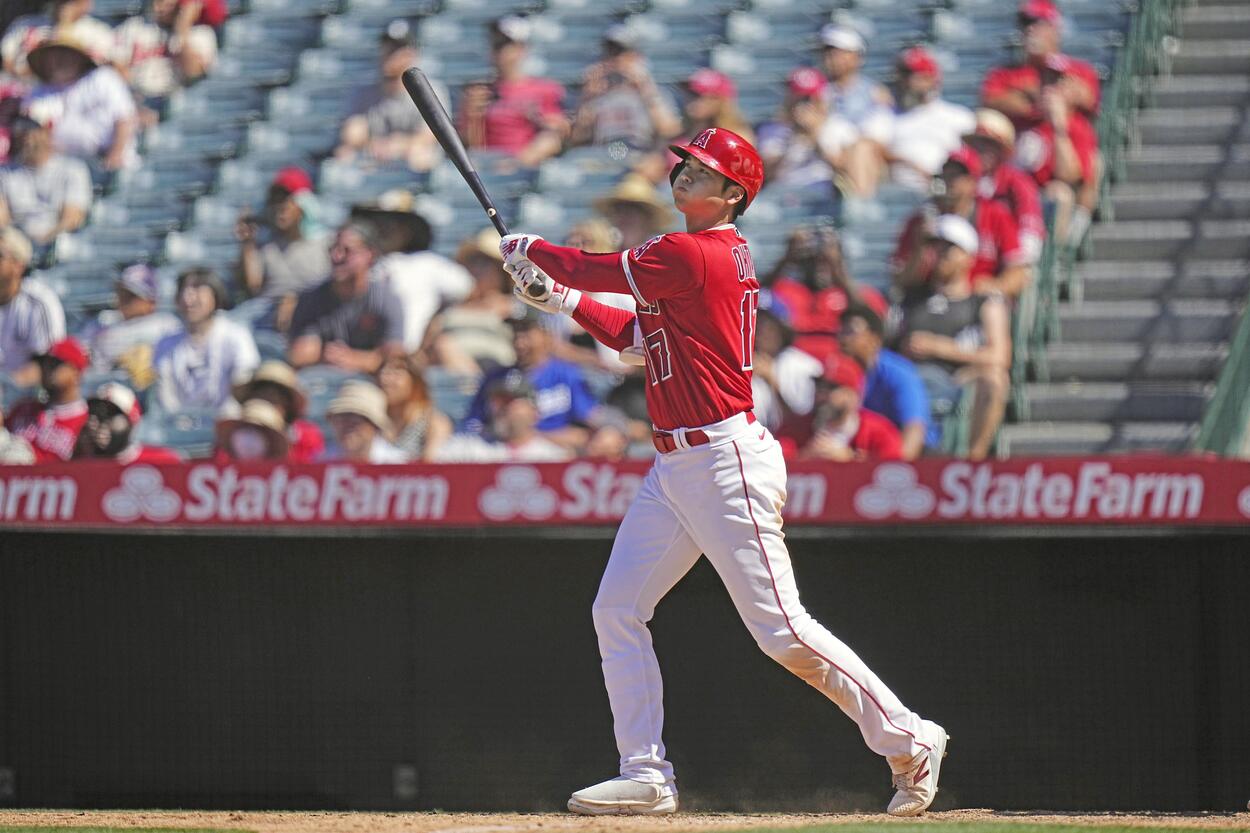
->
[678,429,945,812]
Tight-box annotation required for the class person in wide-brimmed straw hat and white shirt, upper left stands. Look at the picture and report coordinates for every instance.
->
[26,33,139,173]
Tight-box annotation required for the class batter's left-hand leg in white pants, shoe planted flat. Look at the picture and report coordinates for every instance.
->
[569,468,700,813]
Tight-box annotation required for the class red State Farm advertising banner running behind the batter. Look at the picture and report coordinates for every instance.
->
[0,457,1250,528]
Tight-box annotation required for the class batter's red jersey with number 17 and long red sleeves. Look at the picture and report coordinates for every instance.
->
[528,225,760,430]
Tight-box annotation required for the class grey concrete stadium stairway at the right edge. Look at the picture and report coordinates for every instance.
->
[999,0,1250,455]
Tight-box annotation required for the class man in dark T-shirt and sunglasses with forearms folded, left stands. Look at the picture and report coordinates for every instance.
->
[288,220,404,373]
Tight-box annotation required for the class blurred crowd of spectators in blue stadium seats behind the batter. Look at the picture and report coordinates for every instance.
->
[0,0,1124,463]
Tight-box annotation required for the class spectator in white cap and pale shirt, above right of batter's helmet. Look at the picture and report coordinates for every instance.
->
[820,24,894,194]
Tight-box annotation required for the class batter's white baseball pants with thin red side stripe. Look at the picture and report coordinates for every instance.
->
[594,424,928,790]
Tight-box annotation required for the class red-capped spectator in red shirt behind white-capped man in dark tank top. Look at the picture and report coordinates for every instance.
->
[893,145,1033,298]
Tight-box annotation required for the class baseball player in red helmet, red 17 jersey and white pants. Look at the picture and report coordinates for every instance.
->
[500,128,948,815]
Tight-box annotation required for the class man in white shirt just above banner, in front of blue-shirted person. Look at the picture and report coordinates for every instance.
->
[435,369,570,463]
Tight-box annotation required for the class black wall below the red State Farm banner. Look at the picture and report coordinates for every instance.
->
[0,530,1250,810]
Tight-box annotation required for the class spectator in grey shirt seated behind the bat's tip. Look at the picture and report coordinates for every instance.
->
[335,20,451,170]
